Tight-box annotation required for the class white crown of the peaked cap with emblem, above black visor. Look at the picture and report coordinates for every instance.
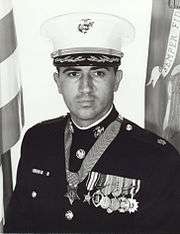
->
[41,12,135,57]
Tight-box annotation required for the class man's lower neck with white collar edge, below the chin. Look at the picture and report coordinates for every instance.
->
[71,105,113,130]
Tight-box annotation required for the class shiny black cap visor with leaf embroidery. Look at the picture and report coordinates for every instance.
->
[53,54,121,67]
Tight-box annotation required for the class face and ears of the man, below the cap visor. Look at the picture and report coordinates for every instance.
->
[54,66,122,126]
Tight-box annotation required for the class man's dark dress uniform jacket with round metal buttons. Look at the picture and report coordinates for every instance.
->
[5,108,180,234]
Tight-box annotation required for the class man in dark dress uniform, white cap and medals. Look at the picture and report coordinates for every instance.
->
[5,13,180,234]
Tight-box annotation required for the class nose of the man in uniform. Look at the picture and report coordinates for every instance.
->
[79,74,93,94]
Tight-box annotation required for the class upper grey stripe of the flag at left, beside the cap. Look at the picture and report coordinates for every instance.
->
[0,10,17,63]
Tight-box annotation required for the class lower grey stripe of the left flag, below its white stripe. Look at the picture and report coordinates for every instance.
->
[0,90,24,155]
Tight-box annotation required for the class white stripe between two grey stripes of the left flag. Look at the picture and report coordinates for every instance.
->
[0,49,21,108]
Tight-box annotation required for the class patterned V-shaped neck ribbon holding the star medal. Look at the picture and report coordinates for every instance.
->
[64,117,122,187]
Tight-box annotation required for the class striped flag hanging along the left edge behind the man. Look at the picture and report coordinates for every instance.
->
[0,0,24,232]
